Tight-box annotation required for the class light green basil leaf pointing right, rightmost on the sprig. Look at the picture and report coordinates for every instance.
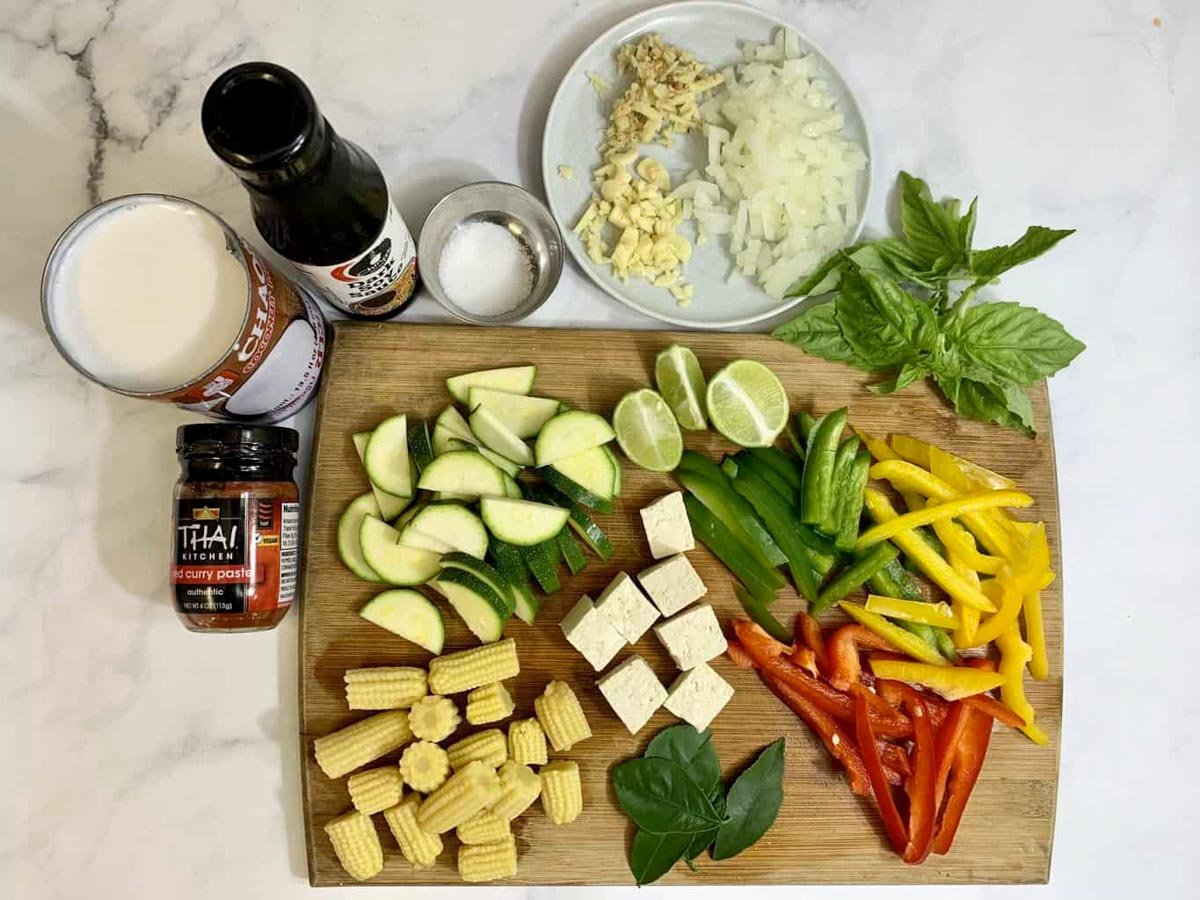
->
[948,302,1084,384]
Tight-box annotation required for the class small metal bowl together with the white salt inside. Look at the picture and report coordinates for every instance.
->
[418,181,563,325]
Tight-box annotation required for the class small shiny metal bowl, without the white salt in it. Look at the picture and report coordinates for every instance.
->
[416,181,563,325]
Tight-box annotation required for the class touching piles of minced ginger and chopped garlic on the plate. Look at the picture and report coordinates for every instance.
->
[574,35,724,306]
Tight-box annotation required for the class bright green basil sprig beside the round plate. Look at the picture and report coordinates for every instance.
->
[774,172,1084,434]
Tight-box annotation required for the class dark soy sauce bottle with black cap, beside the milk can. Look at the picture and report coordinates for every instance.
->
[200,62,416,319]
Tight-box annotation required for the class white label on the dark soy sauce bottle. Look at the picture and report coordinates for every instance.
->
[294,197,416,318]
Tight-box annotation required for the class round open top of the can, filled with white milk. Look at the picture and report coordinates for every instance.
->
[52,199,247,392]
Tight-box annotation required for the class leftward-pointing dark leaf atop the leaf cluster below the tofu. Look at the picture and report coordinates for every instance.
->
[612,758,722,834]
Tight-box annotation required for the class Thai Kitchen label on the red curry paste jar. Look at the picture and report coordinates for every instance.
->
[170,494,300,613]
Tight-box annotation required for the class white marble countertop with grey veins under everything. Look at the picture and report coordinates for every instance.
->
[0,0,1200,900]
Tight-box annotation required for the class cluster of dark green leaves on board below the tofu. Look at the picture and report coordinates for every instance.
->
[612,725,784,884]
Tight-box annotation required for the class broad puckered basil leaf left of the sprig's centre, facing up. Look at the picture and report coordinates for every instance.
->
[835,271,937,368]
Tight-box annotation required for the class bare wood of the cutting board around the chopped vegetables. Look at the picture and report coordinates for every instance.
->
[300,323,1062,886]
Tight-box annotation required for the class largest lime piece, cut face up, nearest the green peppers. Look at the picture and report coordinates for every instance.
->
[707,359,787,446]
